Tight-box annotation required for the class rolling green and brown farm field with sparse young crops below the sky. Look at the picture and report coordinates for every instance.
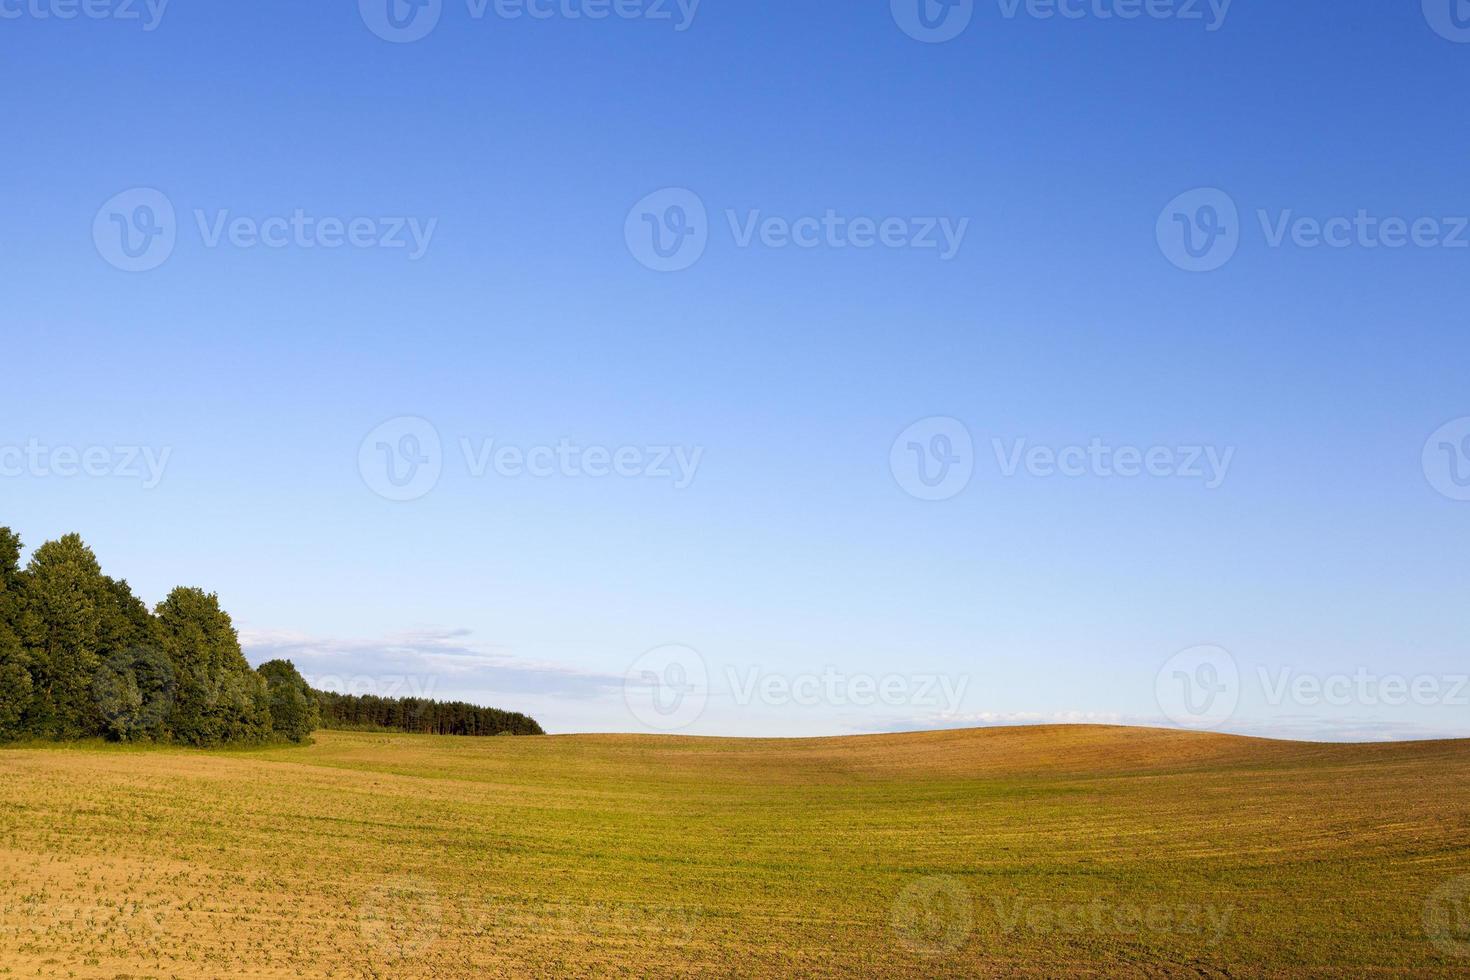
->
[0,727,1470,979]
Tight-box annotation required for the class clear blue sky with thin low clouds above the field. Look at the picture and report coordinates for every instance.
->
[0,0,1470,738]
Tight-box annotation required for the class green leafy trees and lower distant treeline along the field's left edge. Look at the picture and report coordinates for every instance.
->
[0,527,542,746]
